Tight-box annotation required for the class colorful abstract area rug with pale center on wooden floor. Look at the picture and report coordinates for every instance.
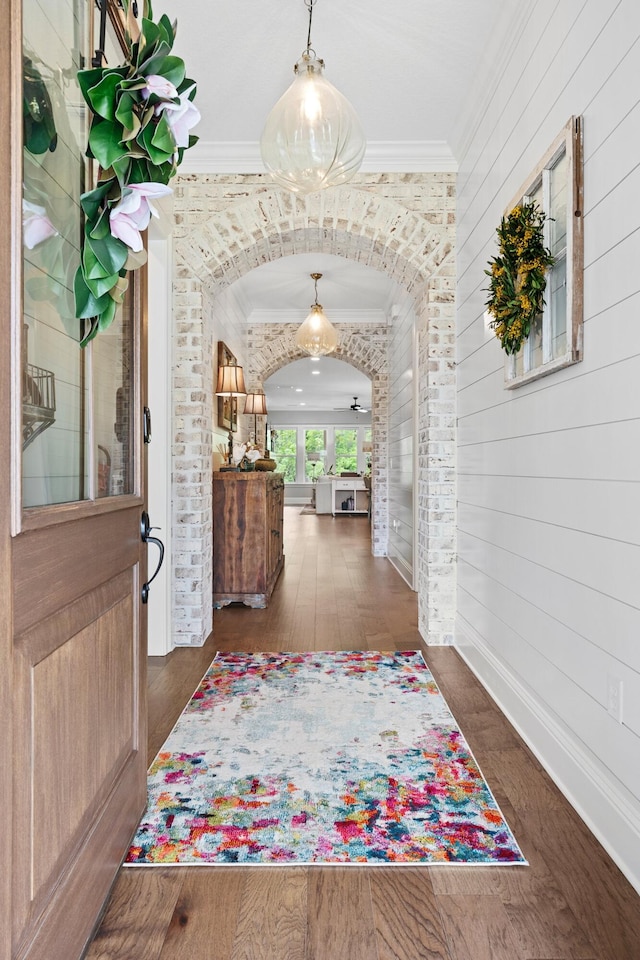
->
[126,652,526,866]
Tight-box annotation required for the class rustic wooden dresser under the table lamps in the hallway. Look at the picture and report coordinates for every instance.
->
[213,471,284,609]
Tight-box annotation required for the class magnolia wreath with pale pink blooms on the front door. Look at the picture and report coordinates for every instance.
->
[74,0,200,346]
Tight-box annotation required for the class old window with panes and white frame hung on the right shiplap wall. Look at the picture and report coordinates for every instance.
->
[505,117,583,387]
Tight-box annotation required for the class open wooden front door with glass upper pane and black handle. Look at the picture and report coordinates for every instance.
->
[0,0,146,960]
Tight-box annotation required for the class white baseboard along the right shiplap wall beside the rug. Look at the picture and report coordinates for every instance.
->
[455,615,640,893]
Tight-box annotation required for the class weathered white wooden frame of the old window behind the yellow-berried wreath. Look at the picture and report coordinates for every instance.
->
[504,117,584,390]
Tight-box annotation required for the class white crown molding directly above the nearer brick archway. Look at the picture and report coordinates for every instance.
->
[180,140,458,174]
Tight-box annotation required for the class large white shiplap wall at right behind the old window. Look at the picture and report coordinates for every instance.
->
[457,0,640,889]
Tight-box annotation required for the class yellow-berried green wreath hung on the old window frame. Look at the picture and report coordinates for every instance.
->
[485,201,554,354]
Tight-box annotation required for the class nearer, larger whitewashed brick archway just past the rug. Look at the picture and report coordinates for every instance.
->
[174,174,455,643]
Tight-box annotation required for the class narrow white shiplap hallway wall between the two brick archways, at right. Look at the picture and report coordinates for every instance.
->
[388,294,415,587]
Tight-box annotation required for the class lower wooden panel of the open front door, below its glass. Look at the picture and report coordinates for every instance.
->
[14,570,144,948]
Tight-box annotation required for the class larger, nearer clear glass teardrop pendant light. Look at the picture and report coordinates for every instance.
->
[260,0,366,193]
